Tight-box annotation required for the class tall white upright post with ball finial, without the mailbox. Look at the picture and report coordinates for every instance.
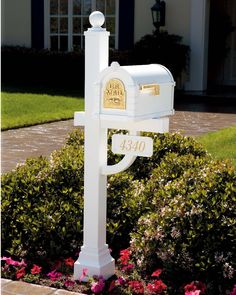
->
[74,11,115,280]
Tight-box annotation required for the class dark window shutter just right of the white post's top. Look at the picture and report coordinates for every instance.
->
[119,0,134,50]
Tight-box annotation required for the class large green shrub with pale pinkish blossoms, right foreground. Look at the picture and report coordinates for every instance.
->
[131,158,236,295]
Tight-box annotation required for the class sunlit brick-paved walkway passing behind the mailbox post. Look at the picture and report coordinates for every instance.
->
[1,111,236,173]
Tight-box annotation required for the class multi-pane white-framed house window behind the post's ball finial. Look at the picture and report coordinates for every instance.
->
[44,0,118,51]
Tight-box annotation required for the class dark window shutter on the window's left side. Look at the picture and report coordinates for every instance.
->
[31,0,44,49]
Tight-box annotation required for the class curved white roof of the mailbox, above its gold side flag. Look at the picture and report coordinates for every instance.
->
[121,64,175,85]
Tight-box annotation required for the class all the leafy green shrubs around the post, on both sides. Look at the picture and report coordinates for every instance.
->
[2,129,236,294]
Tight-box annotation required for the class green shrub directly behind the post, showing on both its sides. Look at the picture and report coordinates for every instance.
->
[2,129,142,260]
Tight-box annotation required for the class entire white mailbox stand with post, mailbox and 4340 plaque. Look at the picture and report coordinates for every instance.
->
[74,11,175,280]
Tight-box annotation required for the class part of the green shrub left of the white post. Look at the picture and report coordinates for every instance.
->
[2,139,83,258]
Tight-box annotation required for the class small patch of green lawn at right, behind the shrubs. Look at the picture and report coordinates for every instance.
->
[198,126,236,167]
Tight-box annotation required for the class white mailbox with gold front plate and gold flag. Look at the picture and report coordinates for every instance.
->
[96,62,175,121]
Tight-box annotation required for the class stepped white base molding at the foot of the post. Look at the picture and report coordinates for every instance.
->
[74,245,115,282]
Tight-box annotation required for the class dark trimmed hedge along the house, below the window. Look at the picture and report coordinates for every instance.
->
[1,32,188,91]
